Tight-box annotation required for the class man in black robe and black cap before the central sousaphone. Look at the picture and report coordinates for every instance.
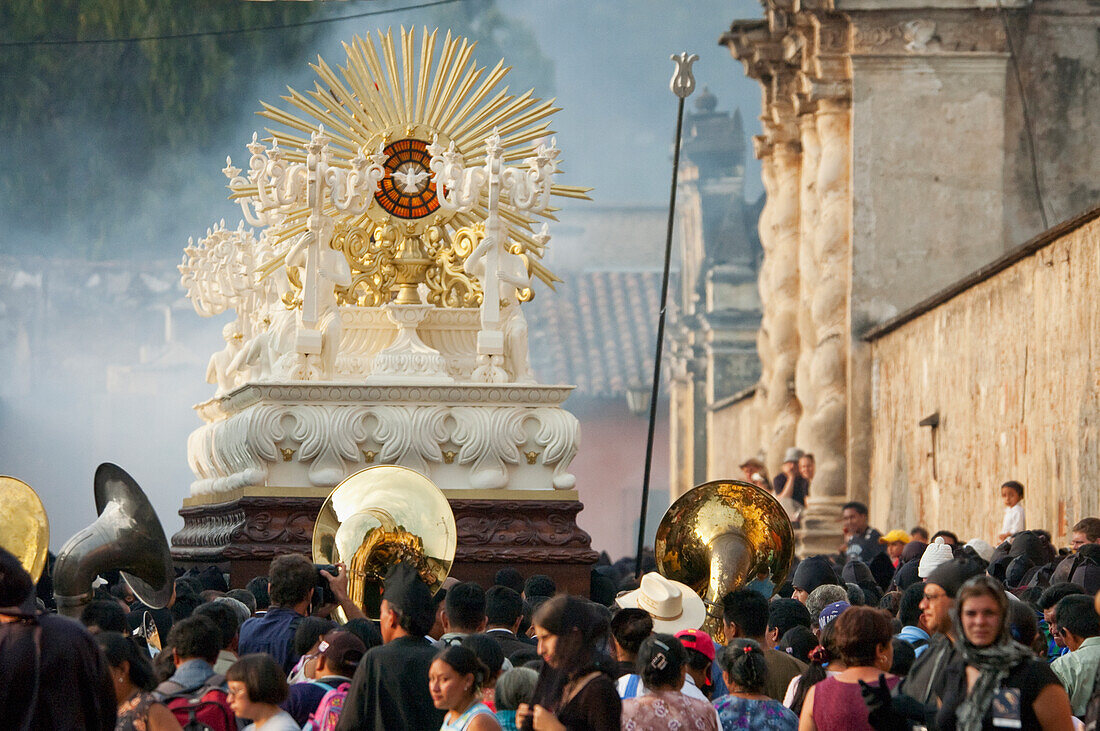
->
[337,564,446,731]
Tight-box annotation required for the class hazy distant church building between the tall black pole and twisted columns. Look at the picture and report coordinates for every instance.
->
[668,89,762,498]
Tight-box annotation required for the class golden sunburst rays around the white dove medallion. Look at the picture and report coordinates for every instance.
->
[231,27,589,286]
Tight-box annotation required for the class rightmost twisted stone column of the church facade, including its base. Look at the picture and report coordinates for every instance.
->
[799,98,851,555]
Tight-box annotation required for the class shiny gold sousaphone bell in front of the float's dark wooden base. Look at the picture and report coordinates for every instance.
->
[312,465,459,619]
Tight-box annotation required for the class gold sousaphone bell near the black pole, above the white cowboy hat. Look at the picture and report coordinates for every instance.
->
[655,480,794,634]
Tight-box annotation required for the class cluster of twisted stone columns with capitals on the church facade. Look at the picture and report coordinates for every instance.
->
[725,3,853,551]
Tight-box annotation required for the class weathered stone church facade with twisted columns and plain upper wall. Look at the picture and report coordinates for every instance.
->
[711,0,1100,551]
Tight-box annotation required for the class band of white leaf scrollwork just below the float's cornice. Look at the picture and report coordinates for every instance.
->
[188,387,580,496]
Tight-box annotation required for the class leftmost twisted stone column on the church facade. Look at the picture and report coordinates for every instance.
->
[765,134,802,474]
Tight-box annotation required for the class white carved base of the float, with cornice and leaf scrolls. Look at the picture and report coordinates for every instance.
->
[187,383,580,497]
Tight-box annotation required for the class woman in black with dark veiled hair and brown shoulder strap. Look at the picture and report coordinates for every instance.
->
[516,595,623,731]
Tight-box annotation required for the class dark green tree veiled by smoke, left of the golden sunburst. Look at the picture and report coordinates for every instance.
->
[0,0,332,257]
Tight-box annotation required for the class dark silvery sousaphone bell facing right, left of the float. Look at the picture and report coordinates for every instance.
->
[54,463,175,617]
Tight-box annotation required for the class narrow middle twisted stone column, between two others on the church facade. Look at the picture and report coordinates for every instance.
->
[794,110,821,452]
